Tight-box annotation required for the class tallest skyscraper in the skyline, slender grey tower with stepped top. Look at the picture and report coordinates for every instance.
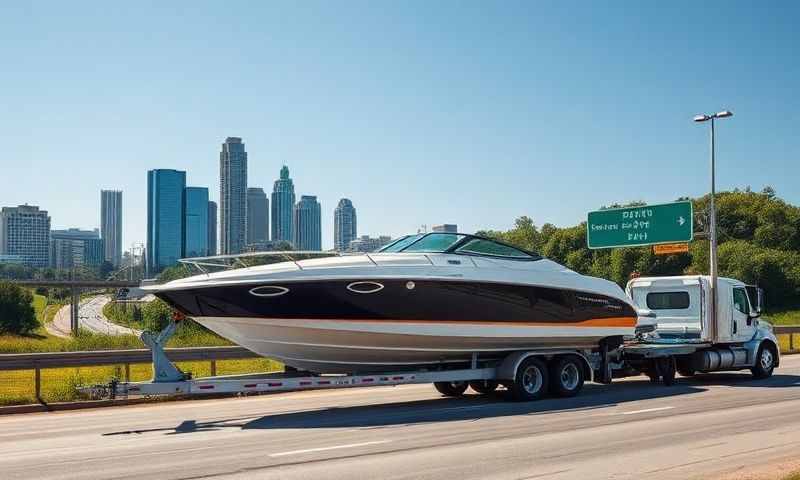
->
[219,137,247,255]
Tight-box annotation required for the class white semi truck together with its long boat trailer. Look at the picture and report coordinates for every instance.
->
[89,275,780,401]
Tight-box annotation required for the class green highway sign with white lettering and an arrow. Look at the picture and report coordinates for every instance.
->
[586,202,694,248]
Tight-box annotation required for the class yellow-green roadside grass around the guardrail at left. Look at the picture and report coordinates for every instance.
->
[0,295,282,405]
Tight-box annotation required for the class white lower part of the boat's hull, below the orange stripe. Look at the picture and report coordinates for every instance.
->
[195,317,630,373]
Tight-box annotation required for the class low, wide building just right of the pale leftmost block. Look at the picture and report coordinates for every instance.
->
[50,228,105,270]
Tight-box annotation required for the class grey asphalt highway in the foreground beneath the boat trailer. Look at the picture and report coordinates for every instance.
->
[0,355,800,480]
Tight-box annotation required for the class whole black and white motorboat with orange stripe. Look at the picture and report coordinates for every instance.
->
[146,232,637,373]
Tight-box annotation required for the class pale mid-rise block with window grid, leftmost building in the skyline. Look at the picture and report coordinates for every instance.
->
[0,205,50,267]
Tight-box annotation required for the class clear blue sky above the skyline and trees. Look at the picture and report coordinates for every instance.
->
[0,1,800,248]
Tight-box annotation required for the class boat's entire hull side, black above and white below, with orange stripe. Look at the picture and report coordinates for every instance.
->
[157,277,636,373]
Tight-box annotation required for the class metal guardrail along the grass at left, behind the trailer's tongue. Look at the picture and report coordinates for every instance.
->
[0,346,260,401]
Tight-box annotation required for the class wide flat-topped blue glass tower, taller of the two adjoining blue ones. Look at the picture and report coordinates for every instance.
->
[147,169,186,274]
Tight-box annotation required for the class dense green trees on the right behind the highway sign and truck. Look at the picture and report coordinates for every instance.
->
[478,187,800,307]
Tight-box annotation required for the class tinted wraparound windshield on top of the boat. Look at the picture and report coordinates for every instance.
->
[379,232,541,260]
